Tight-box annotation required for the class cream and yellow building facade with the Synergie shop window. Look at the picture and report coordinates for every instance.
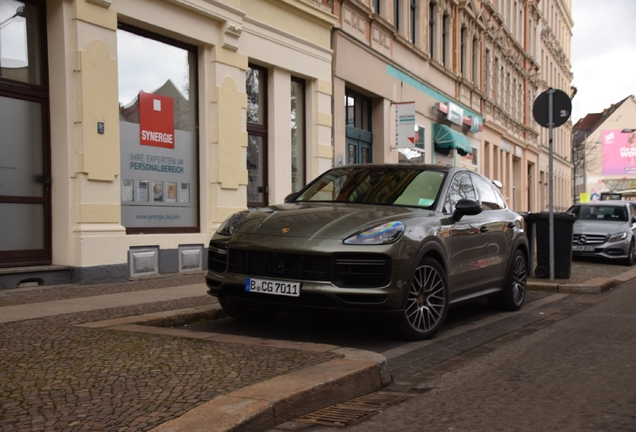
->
[0,0,335,287]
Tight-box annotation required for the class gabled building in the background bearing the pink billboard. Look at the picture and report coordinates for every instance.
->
[572,95,636,202]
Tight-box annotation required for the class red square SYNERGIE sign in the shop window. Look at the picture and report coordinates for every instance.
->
[139,92,174,148]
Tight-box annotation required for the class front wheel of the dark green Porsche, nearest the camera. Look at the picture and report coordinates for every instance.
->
[398,257,448,340]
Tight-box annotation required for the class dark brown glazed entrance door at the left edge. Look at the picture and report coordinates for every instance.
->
[0,0,51,267]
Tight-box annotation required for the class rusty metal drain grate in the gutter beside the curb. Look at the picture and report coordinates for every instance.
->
[295,392,416,426]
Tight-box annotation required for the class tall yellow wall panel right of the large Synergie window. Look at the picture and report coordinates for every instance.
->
[217,77,247,189]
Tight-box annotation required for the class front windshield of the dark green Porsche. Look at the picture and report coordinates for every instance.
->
[294,167,445,208]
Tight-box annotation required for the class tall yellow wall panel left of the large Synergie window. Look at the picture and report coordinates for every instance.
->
[79,39,119,181]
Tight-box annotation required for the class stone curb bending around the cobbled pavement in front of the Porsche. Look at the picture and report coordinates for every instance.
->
[77,304,392,432]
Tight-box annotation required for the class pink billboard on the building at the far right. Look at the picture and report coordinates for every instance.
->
[601,130,636,175]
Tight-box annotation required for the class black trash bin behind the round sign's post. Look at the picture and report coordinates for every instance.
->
[530,212,576,279]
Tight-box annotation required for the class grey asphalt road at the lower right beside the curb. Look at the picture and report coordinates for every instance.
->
[264,281,636,432]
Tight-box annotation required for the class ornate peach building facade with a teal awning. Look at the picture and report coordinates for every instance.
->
[333,0,573,212]
